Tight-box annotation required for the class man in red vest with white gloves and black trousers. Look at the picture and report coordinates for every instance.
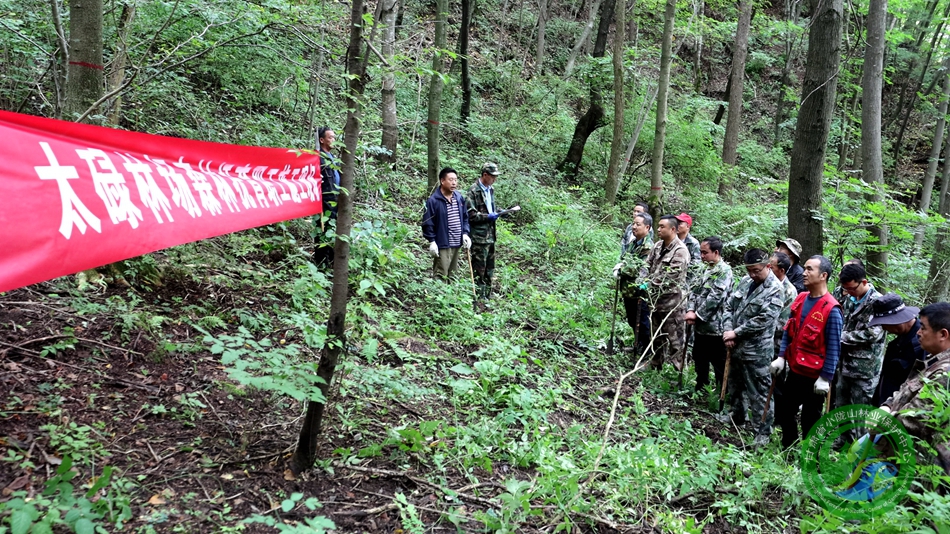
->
[769,256,844,449]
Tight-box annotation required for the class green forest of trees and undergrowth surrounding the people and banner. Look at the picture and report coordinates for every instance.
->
[0,0,950,534]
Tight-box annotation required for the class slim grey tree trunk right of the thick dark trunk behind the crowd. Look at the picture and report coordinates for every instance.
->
[861,0,887,278]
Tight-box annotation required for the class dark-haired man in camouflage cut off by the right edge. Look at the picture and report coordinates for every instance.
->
[881,302,950,475]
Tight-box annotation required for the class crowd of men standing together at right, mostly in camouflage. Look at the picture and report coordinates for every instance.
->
[613,209,950,473]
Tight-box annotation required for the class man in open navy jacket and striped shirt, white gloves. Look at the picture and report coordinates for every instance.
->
[422,167,472,277]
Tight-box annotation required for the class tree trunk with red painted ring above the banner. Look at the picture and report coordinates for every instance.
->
[65,0,105,122]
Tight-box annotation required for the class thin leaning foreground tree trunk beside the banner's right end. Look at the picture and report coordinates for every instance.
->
[289,0,366,474]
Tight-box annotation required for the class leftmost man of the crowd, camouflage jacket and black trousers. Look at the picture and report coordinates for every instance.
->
[614,212,653,354]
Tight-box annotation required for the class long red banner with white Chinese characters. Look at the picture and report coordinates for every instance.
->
[0,111,322,291]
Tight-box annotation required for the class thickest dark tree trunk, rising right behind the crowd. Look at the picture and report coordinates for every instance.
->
[788,0,843,257]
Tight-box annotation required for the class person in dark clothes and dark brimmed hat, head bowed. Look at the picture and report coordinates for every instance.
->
[868,293,927,406]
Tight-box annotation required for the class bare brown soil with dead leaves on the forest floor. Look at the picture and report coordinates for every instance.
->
[0,258,781,533]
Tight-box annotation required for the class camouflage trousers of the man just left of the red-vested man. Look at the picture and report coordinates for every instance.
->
[726,356,775,436]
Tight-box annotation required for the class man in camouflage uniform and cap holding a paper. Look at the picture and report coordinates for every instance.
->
[465,163,501,300]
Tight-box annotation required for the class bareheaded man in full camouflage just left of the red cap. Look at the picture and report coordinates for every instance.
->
[639,215,689,371]
